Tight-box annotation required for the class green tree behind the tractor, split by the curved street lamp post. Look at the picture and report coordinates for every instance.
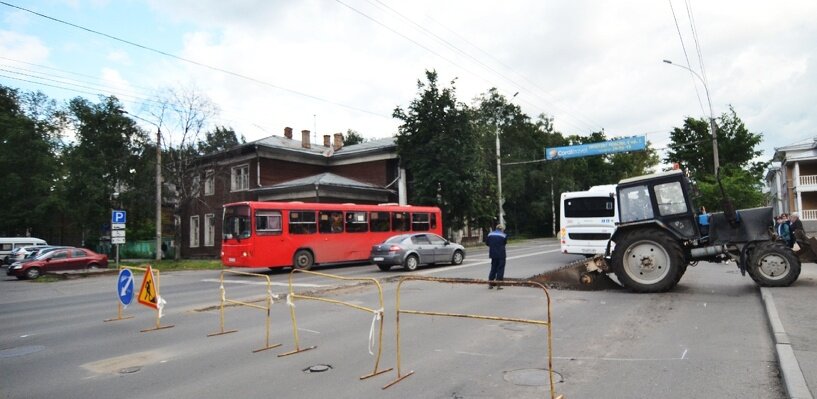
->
[665,106,769,211]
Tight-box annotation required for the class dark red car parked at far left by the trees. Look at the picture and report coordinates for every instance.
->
[6,248,108,280]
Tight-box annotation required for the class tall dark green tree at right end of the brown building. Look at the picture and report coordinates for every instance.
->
[393,71,487,236]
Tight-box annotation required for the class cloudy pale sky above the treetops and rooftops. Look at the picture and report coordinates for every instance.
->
[0,0,817,163]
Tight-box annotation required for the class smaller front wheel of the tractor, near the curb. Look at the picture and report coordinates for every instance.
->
[746,241,800,287]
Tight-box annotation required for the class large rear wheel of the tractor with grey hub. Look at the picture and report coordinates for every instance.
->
[612,229,686,292]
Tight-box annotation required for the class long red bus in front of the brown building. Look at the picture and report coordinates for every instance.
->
[221,202,442,270]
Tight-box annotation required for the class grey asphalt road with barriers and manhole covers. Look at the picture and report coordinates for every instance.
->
[0,240,785,399]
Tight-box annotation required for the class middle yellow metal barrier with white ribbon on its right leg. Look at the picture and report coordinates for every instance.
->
[278,269,392,380]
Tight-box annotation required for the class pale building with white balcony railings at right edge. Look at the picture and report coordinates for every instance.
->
[766,139,817,235]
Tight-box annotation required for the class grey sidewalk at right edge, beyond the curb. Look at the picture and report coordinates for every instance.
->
[760,263,817,399]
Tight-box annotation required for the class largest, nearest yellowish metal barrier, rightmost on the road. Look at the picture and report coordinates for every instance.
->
[383,276,562,399]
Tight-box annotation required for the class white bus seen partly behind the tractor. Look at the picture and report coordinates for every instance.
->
[559,184,619,256]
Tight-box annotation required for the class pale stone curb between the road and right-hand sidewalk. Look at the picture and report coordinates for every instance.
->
[760,287,814,399]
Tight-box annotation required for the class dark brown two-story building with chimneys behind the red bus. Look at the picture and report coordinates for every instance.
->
[177,127,406,258]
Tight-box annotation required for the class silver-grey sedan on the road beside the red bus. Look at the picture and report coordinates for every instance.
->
[369,233,465,271]
